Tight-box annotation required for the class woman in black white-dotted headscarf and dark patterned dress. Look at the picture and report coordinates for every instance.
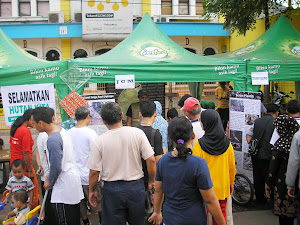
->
[266,115,300,225]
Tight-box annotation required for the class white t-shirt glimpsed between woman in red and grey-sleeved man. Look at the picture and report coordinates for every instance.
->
[36,132,50,181]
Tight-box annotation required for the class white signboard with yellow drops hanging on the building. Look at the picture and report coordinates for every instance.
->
[82,0,133,40]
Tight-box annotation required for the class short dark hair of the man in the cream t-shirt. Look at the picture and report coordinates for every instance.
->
[100,102,122,125]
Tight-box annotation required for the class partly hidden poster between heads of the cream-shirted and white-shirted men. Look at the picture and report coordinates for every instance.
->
[82,93,115,135]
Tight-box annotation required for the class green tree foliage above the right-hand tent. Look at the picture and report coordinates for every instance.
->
[204,0,300,35]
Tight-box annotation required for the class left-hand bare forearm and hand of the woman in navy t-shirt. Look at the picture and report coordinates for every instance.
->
[148,181,163,225]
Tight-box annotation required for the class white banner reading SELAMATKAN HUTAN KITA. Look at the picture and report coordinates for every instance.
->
[1,84,56,126]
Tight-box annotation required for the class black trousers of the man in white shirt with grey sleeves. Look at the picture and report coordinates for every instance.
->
[51,203,80,225]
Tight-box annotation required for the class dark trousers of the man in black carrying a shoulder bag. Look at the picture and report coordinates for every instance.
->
[252,156,270,204]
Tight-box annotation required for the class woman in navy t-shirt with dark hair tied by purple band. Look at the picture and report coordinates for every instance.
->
[149,117,226,225]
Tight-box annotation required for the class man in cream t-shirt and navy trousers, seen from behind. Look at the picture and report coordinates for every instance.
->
[88,102,156,225]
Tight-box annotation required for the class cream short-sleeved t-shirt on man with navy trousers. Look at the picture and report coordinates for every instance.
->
[87,127,154,181]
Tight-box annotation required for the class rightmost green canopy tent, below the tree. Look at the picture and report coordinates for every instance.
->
[210,15,300,91]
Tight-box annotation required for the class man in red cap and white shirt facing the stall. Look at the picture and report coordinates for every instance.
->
[180,97,205,147]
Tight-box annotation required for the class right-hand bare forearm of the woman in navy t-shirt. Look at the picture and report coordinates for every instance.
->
[200,188,226,225]
